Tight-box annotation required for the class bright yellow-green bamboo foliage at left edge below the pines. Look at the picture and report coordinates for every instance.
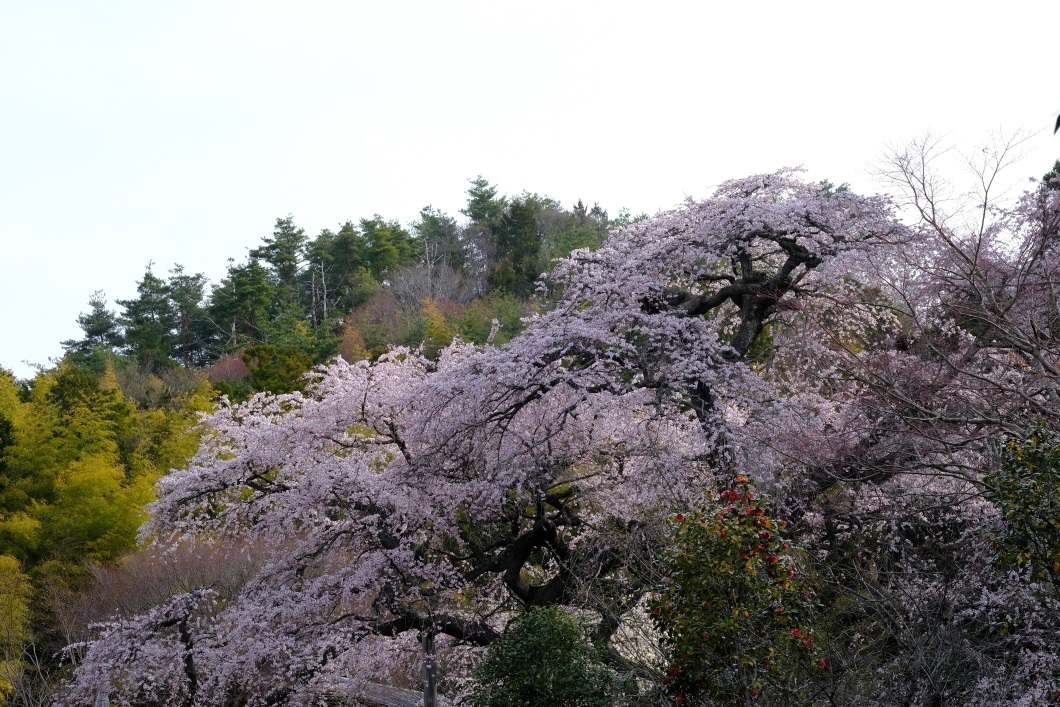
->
[0,363,211,567]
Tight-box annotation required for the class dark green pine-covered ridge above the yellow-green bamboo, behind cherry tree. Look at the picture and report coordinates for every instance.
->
[55,177,629,400]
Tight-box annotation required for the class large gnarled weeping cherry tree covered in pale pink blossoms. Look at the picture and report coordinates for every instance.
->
[62,172,905,704]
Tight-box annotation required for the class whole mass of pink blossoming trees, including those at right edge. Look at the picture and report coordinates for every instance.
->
[58,171,1060,705]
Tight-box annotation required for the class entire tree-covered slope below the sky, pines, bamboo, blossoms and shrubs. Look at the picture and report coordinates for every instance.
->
[0,155,1060,707]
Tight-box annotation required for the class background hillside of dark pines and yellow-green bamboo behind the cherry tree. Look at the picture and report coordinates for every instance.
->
[0,177,629,704]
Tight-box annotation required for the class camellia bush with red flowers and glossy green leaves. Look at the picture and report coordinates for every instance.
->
[652,475,827,705]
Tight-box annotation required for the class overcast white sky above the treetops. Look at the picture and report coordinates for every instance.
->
[0,0,1060,376]
